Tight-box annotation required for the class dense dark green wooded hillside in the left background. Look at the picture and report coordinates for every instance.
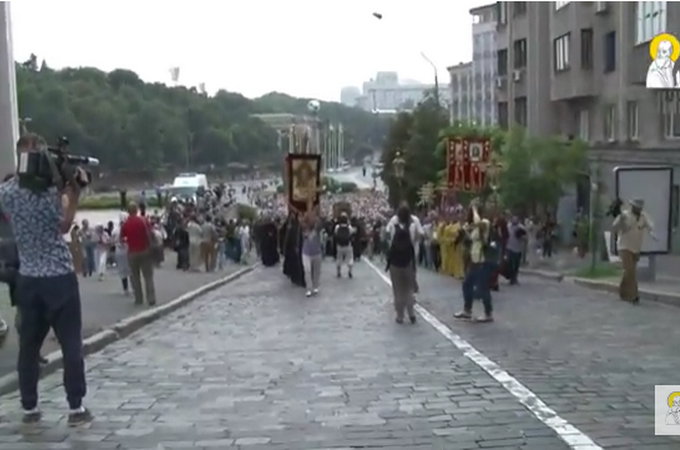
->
[17,57,386,177]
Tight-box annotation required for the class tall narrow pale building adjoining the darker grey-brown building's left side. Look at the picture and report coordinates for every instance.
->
[470,3,498,125]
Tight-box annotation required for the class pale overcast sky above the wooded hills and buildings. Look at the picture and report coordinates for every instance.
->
[11,0,484,100]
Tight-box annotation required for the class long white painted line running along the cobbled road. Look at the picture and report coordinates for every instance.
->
[363,258,604,450]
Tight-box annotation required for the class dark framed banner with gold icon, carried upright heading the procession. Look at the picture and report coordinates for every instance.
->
[286,153,321,214]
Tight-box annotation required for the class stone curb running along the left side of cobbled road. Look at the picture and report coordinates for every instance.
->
[0,264,258,395]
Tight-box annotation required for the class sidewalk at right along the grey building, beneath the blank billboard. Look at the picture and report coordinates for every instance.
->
[522,250,680,306]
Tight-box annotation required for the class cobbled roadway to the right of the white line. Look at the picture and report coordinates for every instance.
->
[412,270,680,450]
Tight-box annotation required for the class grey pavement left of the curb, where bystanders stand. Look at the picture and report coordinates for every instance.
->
[0,253,243,376]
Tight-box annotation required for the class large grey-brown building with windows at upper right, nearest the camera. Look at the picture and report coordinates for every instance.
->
[496,1,680,246]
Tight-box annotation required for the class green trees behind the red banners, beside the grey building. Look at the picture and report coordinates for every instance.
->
[382,102,587,213]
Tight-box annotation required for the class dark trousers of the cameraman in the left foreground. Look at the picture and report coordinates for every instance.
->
[15,273,87,410]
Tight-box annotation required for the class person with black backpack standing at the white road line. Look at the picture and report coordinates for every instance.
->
[387,205,418,324]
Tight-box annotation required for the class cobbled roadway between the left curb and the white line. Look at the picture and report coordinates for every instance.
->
[0,264,567,450]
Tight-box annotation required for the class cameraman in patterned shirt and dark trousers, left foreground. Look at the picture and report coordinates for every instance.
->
[0,134,92,426]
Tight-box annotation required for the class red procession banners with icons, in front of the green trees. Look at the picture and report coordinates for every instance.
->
[446,138,491,192]
